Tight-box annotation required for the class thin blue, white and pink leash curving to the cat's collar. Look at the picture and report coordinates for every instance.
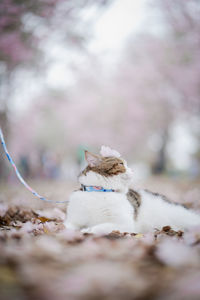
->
[0,128,68,203]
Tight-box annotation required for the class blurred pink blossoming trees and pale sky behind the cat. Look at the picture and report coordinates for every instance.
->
[0,0,200,199]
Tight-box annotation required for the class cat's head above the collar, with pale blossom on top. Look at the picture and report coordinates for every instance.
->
[79,146,133,192]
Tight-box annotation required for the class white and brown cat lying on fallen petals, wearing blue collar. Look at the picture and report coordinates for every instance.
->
[64,146,200,235]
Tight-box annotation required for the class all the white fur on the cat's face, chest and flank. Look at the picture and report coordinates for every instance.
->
[65,155,200,235]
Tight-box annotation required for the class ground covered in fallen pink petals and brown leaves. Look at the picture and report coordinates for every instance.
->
[0,178,200,300]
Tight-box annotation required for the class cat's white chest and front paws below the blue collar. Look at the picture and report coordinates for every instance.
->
[65,191,135,234]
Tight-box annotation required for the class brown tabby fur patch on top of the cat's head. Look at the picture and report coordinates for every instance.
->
[82,156,126,177]
